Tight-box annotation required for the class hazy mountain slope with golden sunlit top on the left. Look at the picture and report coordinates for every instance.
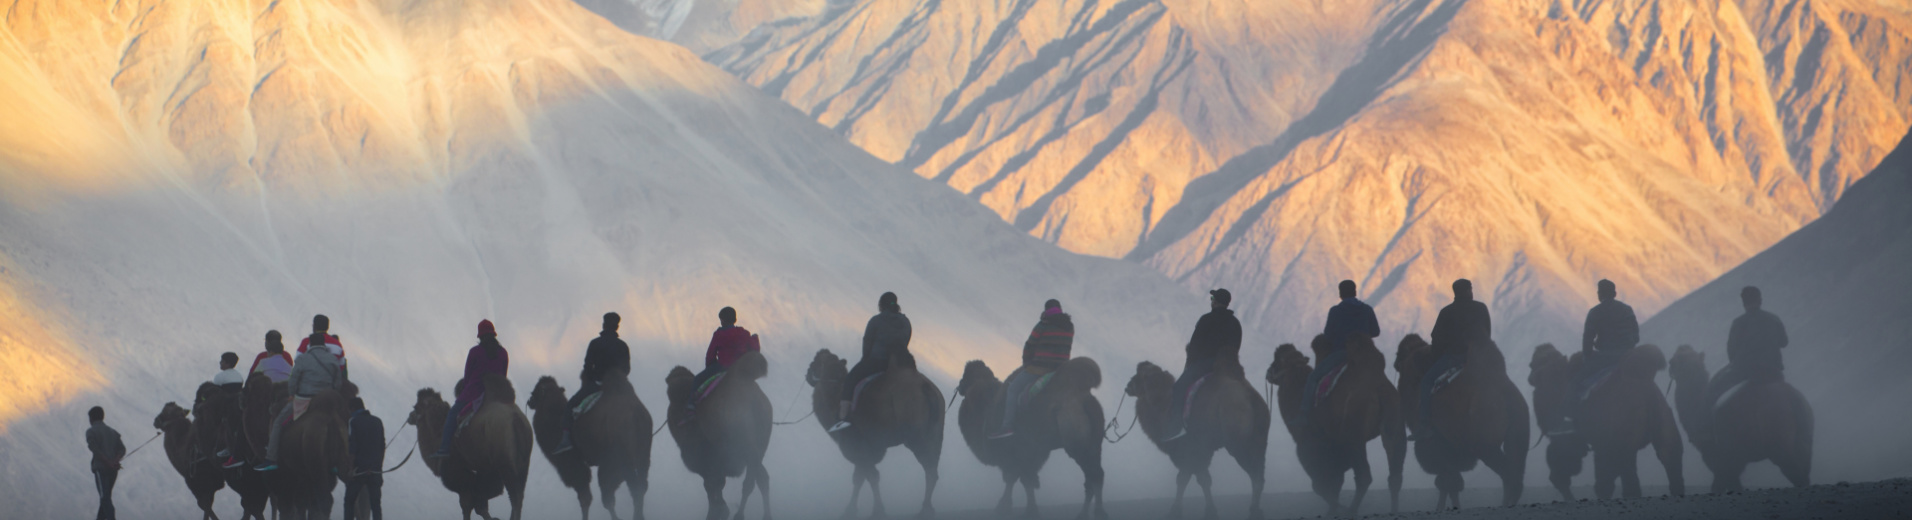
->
[0,0,1206,518]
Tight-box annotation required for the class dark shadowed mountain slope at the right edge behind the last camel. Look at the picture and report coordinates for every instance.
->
[1640,125,1912,478]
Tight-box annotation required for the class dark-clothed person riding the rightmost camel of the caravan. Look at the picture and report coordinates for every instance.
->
[1688,285,1788,440]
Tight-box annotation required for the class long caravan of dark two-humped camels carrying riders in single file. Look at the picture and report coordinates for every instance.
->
[153,279,1814,520]
